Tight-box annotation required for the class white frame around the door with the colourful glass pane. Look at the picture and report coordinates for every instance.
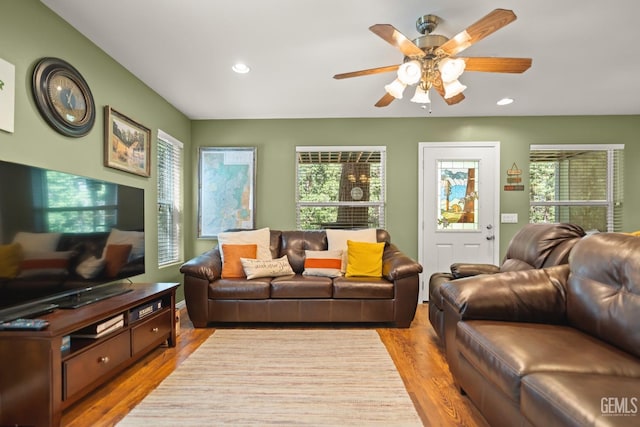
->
[418,141,501,303]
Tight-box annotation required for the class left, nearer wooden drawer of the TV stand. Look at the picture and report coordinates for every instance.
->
[62,330,131,400]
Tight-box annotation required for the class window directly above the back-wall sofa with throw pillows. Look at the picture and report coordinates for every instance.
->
[296,146,386,230]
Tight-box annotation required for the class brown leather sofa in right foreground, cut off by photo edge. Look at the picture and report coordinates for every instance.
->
[441,233,640,427]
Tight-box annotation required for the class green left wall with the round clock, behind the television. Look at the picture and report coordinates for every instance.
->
[0,0,191,299]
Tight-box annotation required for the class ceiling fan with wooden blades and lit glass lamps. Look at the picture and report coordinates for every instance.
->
[333,9,532,107]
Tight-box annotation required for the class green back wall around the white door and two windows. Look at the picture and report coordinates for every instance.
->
[190,116,640,258]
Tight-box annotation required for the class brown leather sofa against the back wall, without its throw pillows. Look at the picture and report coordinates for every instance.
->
[180,230,422,328]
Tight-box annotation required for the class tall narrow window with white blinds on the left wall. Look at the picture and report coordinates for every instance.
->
[158,130,182,266]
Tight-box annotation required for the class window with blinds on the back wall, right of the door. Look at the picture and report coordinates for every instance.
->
[529,144,624,232]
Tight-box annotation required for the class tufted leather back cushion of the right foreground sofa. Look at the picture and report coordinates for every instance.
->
[567,233,640,357]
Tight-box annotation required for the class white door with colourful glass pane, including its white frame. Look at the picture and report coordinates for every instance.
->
[418,142,500,301]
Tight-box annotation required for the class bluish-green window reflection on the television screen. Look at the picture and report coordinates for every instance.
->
[32,170,118,233]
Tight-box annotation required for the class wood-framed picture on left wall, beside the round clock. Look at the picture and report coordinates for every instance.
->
[104,105,151,176]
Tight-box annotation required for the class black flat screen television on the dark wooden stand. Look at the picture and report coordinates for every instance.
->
[0,160,145,321]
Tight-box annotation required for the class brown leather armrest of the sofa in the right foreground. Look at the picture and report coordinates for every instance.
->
[440,264,569,323]
